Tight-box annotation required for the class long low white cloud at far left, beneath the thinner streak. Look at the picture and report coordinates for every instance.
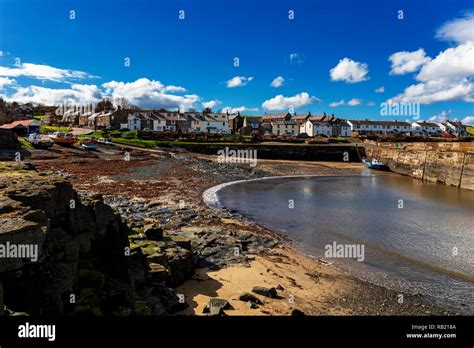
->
[6,84,102,105]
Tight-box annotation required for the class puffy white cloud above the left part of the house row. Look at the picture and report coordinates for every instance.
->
[102,78,200,110]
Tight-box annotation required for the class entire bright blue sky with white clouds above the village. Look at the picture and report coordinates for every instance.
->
[0,0,474,124]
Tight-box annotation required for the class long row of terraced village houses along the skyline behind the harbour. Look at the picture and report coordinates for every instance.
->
[51,109,467,137]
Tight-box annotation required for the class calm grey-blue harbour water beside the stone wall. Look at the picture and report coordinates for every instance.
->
[218,175,474,312]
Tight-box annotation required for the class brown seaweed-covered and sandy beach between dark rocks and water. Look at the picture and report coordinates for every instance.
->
[25,143,470,315]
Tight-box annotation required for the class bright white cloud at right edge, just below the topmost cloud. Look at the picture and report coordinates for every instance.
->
[416,41,474,81]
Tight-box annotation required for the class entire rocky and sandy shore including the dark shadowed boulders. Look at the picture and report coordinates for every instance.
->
[0,144,466,316]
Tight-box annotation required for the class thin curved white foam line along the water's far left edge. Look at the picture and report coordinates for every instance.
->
[202,173,376,208]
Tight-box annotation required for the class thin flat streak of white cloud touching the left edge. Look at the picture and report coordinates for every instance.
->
[0,63,95,82]
